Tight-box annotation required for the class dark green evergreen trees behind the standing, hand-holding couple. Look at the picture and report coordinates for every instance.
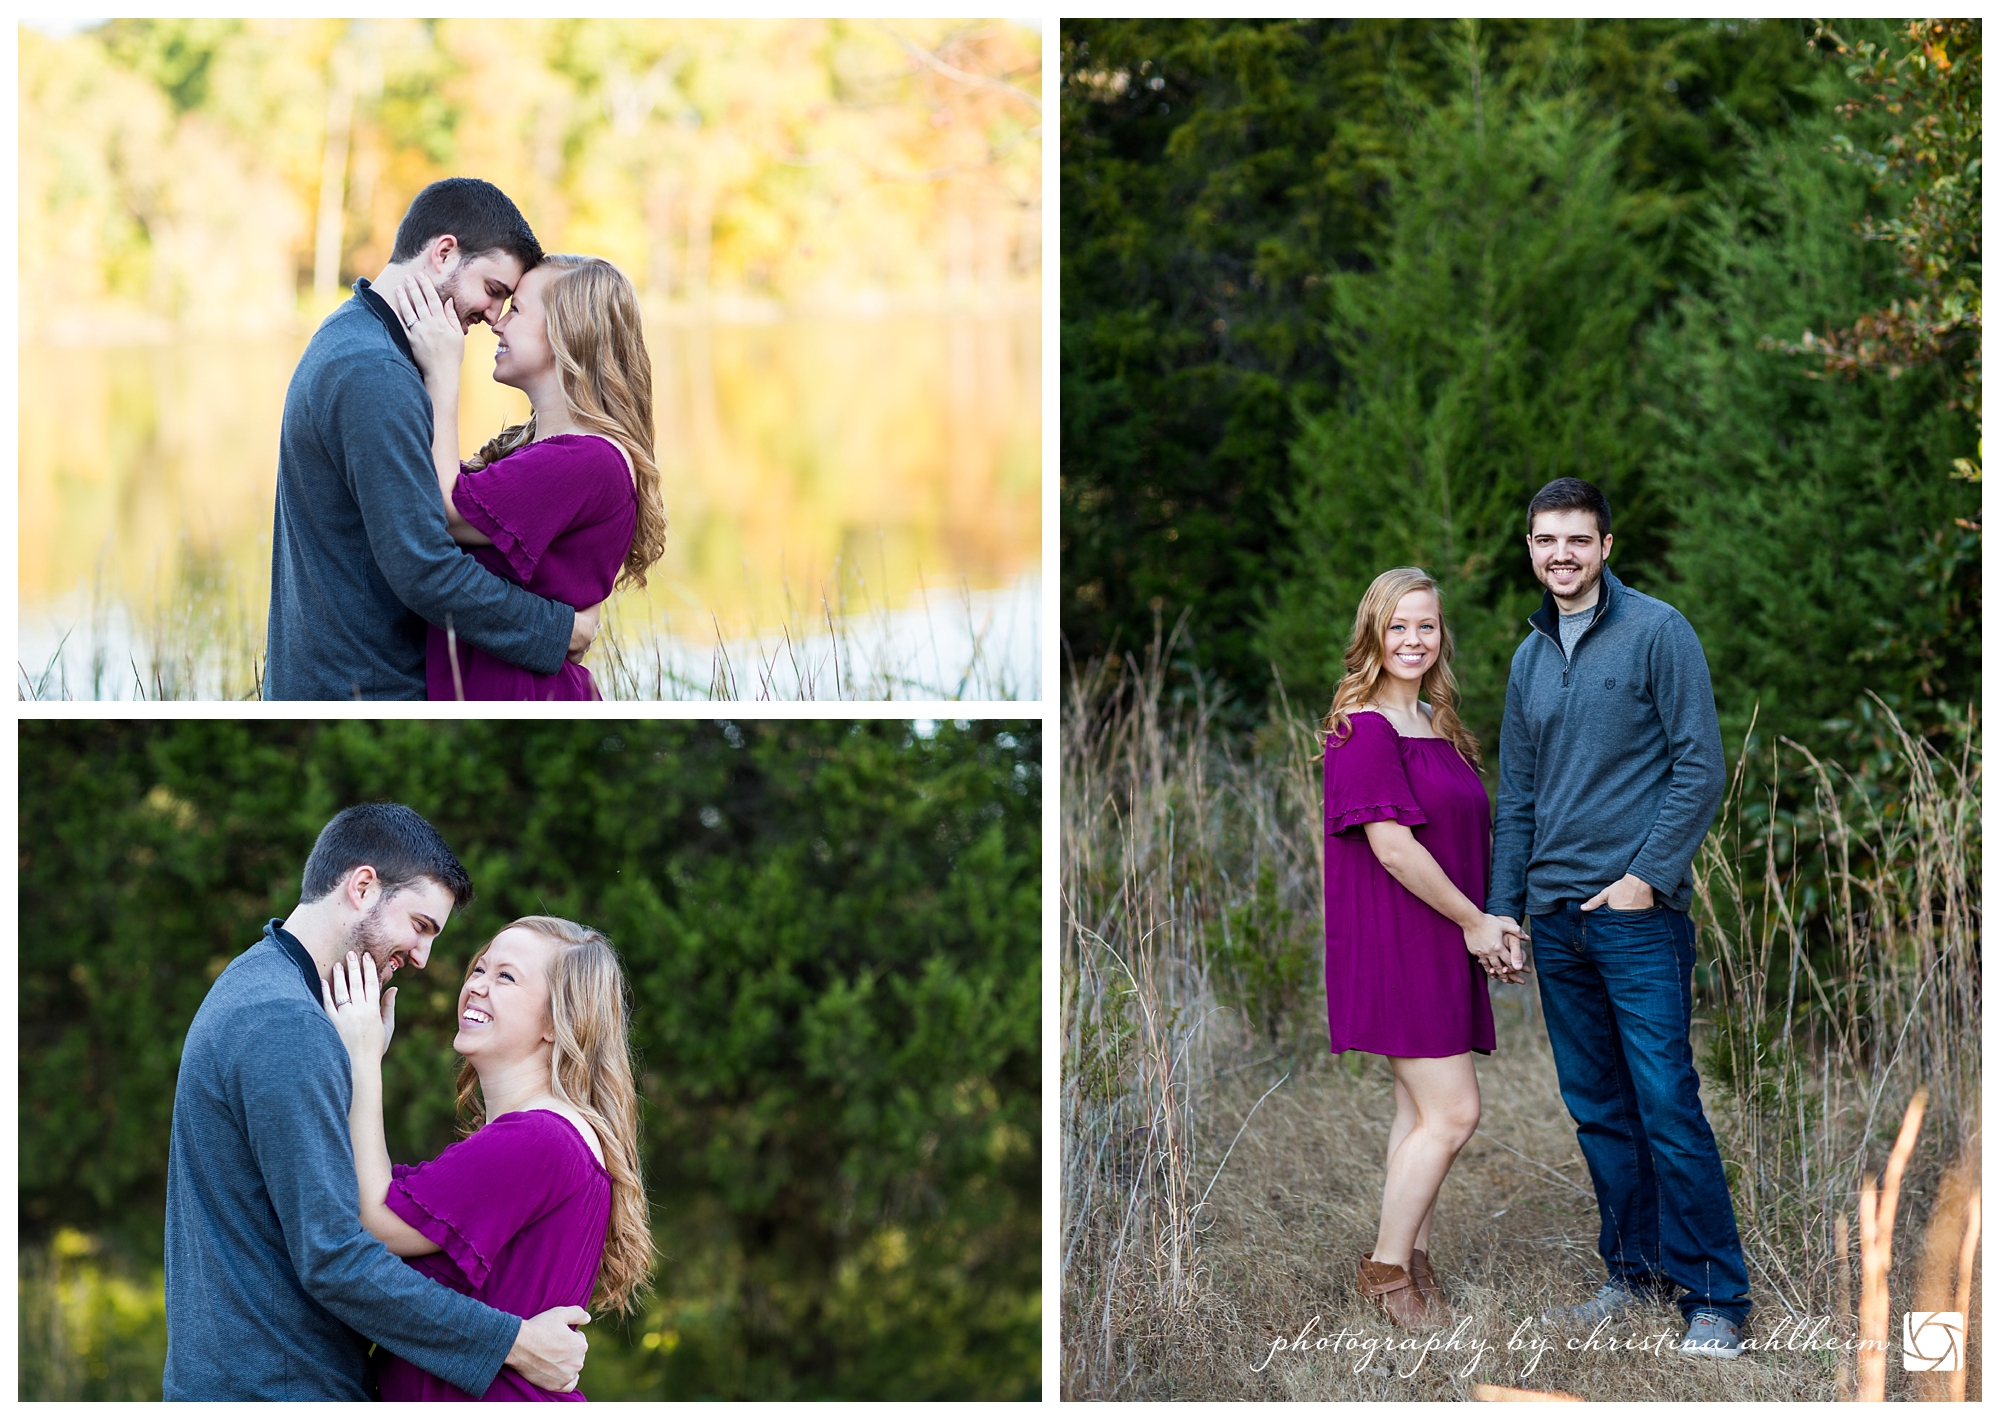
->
[1060,20,1980,748]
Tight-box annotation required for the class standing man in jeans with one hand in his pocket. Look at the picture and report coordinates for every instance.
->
[1486,478,1750,1360]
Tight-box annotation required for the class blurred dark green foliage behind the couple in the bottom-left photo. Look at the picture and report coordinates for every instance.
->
[20,720,1042,1400]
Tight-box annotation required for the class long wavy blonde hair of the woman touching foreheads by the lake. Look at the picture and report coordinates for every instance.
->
[466,252,666,586]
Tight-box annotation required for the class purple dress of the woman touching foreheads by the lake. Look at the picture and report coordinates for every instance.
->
[424,434,638,700]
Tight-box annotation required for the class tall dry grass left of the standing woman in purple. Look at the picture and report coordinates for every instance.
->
[1062,646,1320,1396]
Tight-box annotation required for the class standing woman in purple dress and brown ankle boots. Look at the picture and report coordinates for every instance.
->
[1326,568,1520,1326]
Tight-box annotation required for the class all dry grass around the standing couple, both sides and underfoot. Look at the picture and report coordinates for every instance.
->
[1060,644,1978,1400]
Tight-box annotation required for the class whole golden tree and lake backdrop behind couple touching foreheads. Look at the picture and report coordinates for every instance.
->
[18,18,1042,698]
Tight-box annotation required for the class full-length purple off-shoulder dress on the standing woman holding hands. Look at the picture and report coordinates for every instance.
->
[1326,710,1494,1058]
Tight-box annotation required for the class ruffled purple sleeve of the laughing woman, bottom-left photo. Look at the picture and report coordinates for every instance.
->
[386,1110,582,1286]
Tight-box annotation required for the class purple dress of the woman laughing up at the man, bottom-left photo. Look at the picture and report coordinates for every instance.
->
[378,1110,612,1400]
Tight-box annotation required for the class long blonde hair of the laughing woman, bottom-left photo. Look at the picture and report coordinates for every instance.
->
[458,918,652,1312]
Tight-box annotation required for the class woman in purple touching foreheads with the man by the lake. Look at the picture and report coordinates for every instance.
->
[390,254,666,700]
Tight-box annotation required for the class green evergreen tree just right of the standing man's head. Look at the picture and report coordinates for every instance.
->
[1646,104,1980,744]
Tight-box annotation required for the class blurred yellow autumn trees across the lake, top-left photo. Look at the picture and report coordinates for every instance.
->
[20,20,1042,334]
